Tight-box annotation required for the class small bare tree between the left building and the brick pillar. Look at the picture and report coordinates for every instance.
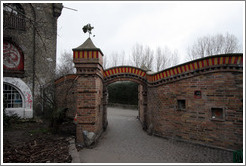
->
[56,51,76,77]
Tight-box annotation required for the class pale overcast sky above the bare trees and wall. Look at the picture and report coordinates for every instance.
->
[57,1,245,67]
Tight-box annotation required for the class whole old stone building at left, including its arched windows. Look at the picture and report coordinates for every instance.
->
[2,3,63,118]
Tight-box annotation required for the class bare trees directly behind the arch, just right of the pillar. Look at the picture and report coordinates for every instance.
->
[103,43,179,71]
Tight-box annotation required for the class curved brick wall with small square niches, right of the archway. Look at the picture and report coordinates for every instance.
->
[147,54,243,150]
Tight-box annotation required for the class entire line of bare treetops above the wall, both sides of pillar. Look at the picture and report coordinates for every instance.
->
[57,33,242,77]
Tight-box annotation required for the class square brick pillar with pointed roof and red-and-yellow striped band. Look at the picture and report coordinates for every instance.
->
[73,38,103,144]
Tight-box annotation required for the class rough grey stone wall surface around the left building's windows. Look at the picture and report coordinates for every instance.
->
[3,3,62,116]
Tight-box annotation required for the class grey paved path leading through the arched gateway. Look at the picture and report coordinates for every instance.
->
[79,108,233,163]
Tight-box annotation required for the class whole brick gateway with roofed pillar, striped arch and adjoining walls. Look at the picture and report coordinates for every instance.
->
[56,38,243,150]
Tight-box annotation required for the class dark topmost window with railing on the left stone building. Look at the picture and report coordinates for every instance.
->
[3,3,26,30]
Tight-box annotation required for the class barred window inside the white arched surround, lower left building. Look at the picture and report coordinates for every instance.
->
[3,84,22,108]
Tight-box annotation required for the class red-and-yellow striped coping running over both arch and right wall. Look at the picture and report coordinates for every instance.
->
[103,54,243,85]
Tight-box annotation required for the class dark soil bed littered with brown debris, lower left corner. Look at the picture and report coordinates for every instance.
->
[3,120,75,163]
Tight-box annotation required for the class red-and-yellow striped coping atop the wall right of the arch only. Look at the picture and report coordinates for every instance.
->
[147,54,243,85]
